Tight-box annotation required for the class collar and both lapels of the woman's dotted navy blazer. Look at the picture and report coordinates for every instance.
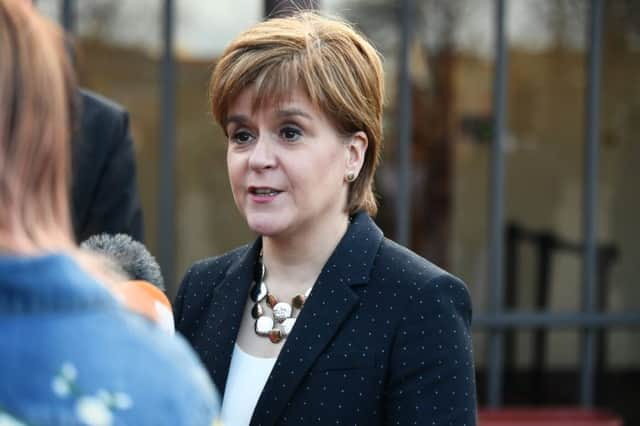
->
[205,212,383,425]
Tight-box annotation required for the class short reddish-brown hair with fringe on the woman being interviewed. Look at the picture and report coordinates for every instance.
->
[209,12,384,215]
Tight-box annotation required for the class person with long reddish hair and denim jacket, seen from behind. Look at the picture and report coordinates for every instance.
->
[0,0,218,426]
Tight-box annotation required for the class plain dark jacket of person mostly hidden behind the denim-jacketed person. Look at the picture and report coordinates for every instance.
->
[71,90,143,242]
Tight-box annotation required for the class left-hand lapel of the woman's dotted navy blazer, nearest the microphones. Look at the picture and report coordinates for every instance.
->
[205,238,262,395]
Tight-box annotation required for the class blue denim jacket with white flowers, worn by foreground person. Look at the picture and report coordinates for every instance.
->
[0,254,219,426]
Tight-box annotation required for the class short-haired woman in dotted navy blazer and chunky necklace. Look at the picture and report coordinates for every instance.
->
[175,12,475,426]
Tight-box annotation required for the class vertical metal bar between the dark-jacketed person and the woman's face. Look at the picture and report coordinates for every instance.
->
[157,0,176,289]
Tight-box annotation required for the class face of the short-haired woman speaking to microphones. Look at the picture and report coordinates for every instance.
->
[225,87,356,237]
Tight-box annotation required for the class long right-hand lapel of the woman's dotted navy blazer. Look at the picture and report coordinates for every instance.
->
[251,213,383,426]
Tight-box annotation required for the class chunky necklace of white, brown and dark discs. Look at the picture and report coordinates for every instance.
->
[249,253,311,343]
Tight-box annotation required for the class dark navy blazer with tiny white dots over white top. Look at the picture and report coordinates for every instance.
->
[175,213,476,426]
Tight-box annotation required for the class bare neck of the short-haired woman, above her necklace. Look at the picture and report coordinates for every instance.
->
[262,214,349,293]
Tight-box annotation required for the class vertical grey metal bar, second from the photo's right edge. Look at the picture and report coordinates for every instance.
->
[487,0,508,408]
